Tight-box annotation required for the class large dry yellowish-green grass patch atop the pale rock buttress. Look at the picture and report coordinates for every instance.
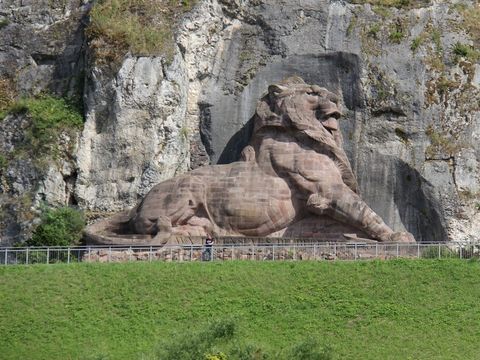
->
[86,0,196,64]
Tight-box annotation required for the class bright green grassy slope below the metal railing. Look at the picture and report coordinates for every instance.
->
[0,260,480,360]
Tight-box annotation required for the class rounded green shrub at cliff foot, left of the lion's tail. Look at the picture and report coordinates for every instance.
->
[27,206,85,246]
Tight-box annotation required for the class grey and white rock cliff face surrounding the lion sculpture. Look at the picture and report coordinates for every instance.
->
[0,0,480,241]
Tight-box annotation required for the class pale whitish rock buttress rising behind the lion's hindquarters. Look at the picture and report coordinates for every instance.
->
[75,57,187,211]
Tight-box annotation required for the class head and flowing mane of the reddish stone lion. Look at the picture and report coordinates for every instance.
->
[253,76,357,191]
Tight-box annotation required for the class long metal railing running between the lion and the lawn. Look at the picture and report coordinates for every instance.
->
[0,242,480,265]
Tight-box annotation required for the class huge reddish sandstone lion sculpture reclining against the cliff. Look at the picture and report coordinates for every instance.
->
[86,77,414,244]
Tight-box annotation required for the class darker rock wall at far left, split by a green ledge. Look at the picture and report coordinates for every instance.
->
[0,0,90,245]
